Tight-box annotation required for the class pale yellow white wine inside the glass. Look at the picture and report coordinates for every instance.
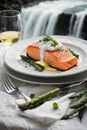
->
[0,31,21,44]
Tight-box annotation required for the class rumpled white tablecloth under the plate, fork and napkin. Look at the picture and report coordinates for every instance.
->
[0,43,87,130]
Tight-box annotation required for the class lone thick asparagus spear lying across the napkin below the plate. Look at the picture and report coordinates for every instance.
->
[18,88,60,111]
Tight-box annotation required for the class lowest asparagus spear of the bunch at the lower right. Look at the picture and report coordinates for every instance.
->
[61,103,87,120]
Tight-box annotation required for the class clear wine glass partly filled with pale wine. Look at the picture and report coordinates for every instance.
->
[0,10,21,44]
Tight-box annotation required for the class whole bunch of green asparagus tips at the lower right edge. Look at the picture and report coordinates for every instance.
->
[62,90,87,119]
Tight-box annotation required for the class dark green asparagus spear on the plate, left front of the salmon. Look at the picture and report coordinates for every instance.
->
[21,55,44,72]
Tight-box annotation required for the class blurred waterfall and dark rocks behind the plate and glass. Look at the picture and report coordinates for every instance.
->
[0,0,87,40]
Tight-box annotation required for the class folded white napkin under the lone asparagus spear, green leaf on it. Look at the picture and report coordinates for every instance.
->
[17,93,73,124]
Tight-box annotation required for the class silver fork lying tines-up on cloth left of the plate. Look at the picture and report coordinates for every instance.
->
[1,72,31,101]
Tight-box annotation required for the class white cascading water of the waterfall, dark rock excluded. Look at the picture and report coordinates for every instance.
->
[22,0,87,38]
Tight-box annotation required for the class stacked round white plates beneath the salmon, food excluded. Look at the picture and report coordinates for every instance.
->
[4,36,87,84]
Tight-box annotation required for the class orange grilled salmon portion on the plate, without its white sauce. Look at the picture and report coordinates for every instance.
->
[26,41,78,70]
